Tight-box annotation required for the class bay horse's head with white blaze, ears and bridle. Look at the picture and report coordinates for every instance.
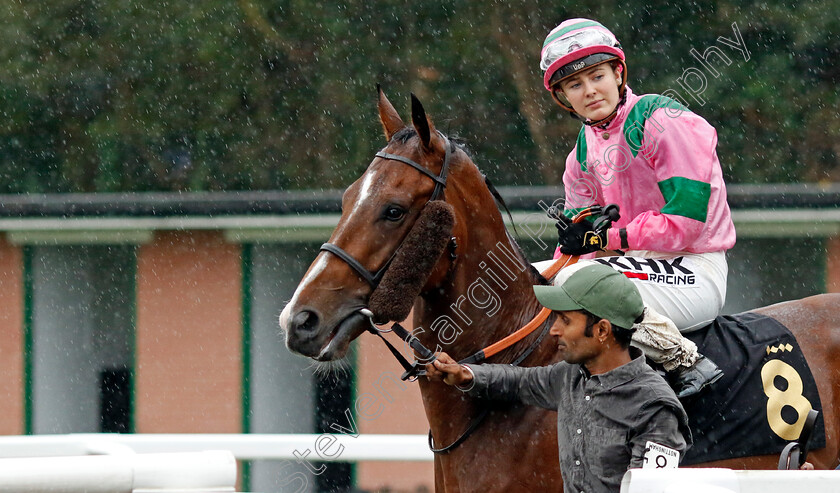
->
[280,90,470,361]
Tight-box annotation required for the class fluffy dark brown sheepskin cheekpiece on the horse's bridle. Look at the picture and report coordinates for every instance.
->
[368,200,455,323]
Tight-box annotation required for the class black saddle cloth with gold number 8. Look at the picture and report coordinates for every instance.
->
[682,312,825,465]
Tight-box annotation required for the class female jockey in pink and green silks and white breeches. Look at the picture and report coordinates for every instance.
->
[540,19,735,398]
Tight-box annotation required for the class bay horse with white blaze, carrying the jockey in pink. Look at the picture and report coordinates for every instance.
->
[280,89,840,492]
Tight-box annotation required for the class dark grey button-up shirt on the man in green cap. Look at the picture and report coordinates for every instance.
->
[468,348,691,493]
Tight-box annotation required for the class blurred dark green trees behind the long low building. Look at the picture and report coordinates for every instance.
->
[0,0,840,193]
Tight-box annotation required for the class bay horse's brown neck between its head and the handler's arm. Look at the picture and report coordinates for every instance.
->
[414,160,556,446]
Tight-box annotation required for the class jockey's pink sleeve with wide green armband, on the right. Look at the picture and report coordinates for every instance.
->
[607,109,722,252]
